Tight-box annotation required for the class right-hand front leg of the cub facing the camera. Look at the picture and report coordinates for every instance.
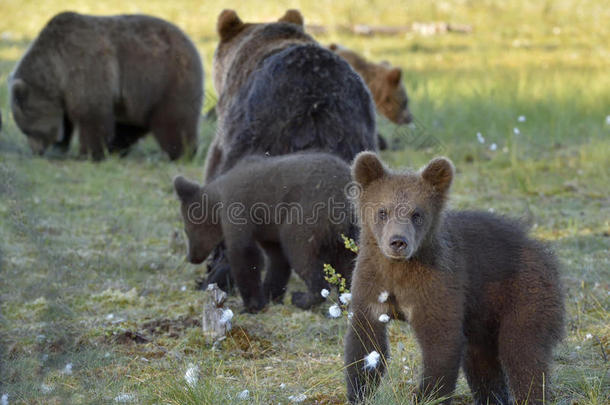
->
[411,309,464,404]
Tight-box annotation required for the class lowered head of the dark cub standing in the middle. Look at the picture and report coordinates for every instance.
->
[174,176,222,264]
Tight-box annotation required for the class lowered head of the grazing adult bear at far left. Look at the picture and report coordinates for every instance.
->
[10,79,64,155]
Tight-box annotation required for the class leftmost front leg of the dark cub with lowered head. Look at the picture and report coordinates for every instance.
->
[227,240,267,313]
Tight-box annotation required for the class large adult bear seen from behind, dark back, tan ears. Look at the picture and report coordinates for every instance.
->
[205,10,377,182]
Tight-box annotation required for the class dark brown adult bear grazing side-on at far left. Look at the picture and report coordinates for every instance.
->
[10,12,203,160]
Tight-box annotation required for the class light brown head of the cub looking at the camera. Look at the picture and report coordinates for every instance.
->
[352,152,453,261]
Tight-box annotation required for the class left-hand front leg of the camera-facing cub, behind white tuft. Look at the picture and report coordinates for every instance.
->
[345,302,389,404]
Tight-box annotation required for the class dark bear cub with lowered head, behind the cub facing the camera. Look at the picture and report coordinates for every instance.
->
[174,153,357,312]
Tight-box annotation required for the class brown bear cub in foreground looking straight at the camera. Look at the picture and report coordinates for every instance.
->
[345,152,564,404]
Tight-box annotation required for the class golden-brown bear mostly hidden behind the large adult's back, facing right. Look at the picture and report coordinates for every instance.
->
[329,44,413,124]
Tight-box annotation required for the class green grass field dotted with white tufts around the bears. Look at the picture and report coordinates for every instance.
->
[0,0,610,405]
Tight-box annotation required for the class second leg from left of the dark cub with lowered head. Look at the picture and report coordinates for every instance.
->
[261,243,291,303]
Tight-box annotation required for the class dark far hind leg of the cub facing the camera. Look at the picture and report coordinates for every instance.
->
[463,344,510,405]
